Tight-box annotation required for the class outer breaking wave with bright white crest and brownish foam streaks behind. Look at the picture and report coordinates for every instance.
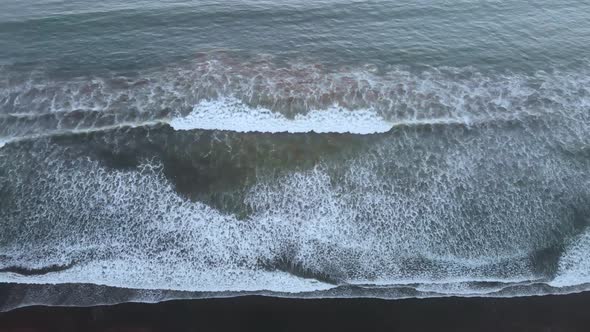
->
[0,52,590,142]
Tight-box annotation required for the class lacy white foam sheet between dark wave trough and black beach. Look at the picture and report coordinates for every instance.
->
[0,132,588,295]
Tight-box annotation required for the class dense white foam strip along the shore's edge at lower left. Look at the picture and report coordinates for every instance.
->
[0,260,335,293]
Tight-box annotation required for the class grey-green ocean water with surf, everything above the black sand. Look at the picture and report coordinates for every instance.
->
[0,0,590,310]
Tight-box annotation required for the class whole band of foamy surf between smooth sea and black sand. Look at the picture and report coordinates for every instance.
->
[0,52,590,309]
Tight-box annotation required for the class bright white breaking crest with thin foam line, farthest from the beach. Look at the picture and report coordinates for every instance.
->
[0,98,475,148]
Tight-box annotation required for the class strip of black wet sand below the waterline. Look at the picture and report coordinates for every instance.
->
[0,293,590,332]
